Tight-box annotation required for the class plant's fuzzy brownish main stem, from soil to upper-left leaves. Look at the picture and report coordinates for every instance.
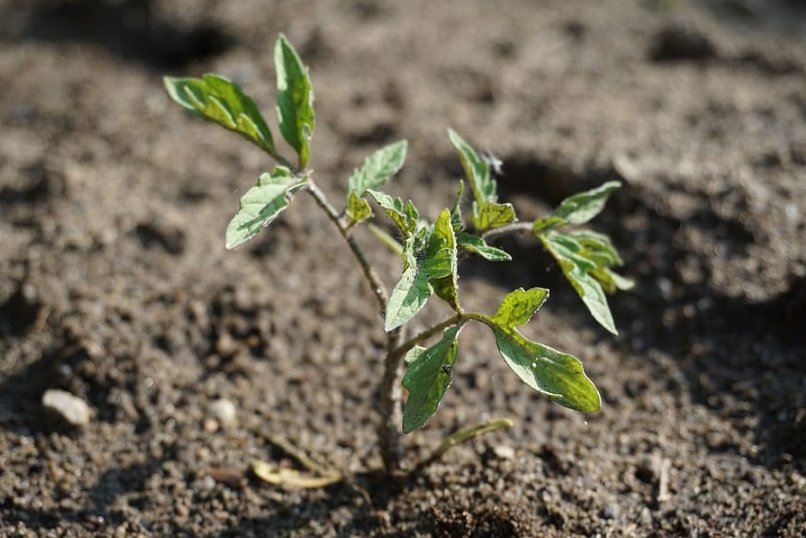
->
[307,180,405,468]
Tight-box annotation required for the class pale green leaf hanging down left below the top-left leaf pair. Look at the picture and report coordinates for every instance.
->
[226,166,308,249]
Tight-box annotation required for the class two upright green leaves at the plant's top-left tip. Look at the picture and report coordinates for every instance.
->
[164,34,315,169]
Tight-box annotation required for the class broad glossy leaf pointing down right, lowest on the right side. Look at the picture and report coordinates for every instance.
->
[493,327,602,413]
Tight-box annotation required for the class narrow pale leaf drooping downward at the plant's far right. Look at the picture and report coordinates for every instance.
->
[537,232,618,334]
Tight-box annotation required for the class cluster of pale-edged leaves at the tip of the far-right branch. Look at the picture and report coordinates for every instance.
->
[533,181,632,334]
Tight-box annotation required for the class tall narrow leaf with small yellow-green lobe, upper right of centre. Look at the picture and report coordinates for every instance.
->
[448,129,517,233]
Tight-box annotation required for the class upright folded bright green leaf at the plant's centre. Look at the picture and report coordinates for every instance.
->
[430,209,459,310]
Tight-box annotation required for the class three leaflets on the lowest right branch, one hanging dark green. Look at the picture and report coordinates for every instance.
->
[403,288,601,433]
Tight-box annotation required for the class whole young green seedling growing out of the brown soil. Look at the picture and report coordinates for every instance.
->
[165,35,632,476]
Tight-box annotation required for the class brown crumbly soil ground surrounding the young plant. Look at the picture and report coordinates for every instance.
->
[0,0,806,537]
